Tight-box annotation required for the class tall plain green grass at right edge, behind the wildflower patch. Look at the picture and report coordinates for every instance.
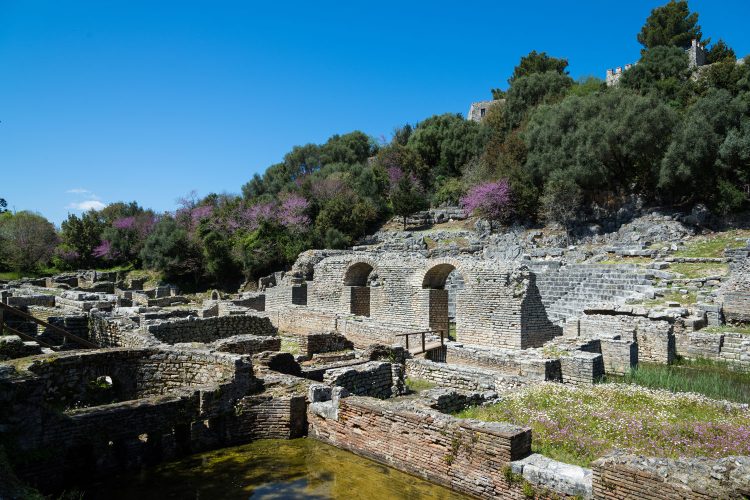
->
[607,359,750,403]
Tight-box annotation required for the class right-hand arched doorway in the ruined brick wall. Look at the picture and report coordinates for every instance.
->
[422,263,464,339]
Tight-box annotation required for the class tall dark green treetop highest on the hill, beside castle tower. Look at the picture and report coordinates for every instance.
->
[638,0,703,53]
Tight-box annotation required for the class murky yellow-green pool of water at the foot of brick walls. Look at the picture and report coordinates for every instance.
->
[84,439,465,500]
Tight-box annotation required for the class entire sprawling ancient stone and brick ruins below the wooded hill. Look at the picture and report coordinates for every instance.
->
[0,221,750,498]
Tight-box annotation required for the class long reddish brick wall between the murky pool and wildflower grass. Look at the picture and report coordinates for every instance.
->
[308,396,531,499]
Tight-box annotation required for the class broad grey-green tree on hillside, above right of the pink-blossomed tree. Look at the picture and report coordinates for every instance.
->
[525,89,677,194]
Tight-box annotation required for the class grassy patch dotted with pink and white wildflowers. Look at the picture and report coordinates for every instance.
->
[457,383,750,467]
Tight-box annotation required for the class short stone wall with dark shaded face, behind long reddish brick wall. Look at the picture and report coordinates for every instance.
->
[323,361,404,399]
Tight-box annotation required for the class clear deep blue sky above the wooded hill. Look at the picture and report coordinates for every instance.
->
[0,0,750,224]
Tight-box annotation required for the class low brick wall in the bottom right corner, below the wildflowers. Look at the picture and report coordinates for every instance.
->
[592,454,750,500]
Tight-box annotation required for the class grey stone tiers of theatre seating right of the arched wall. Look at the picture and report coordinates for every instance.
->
[536,264,652,323]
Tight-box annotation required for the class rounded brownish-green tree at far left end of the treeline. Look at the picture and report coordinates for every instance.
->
[0,211,59,271]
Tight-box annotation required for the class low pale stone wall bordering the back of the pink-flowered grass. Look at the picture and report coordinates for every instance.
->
[406,358,525,392]
